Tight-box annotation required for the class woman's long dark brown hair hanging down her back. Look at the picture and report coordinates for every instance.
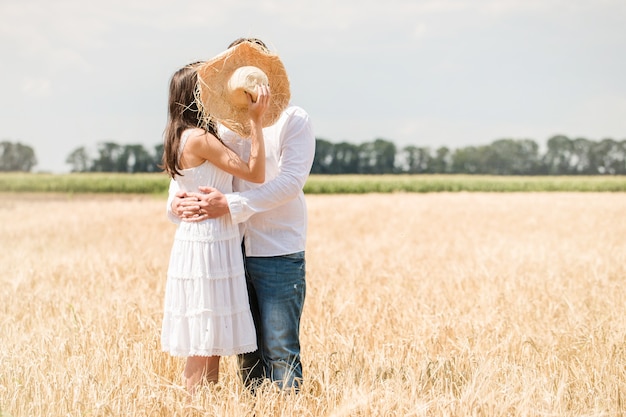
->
[161,62,217,178]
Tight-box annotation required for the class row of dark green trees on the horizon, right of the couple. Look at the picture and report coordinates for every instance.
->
[312,135,626,175]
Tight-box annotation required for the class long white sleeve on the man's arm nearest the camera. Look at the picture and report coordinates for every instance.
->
[226,108,315,223]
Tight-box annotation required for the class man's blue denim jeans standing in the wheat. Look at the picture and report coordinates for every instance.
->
[238,252,306,390]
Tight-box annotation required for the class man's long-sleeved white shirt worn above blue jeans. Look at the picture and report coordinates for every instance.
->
[167,106,315,257]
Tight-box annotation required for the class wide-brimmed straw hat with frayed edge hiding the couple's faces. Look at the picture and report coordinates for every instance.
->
[196,42,291,137]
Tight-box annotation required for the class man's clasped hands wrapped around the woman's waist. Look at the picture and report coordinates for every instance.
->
[172,187,229,222]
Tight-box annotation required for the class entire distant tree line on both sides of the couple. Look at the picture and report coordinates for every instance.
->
[0,135,626,175]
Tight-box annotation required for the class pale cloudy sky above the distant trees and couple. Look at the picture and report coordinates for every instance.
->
[0,0,626,172]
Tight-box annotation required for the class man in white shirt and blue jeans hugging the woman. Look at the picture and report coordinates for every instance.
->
[168,38,315,391]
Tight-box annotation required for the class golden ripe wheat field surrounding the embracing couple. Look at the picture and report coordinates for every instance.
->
[0,193,626,417]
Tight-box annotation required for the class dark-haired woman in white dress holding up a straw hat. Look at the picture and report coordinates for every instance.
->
[161,63,270,393]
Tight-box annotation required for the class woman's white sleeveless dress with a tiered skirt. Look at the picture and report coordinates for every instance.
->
[161,131,257,357]
